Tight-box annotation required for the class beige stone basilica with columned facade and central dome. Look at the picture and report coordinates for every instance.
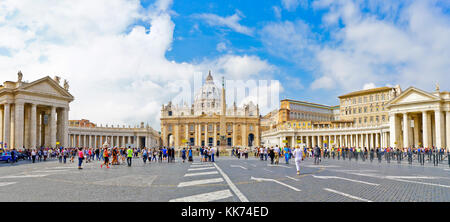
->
[161,72,260,148]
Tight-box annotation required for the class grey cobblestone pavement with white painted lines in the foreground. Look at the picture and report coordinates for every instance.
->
[0,157,450,202]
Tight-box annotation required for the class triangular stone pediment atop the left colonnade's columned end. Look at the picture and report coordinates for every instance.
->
[20,77,73,99]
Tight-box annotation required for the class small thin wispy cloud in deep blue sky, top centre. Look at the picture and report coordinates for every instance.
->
[194,10,254,36]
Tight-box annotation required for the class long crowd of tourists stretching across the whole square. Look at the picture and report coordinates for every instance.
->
[0,145,450,172]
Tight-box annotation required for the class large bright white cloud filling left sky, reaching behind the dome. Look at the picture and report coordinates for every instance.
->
[0,0,272,130]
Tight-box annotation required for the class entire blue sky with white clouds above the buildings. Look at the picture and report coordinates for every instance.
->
[0,0,450,129]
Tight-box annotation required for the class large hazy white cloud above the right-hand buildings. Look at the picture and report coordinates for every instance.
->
[312,1,450,89]
